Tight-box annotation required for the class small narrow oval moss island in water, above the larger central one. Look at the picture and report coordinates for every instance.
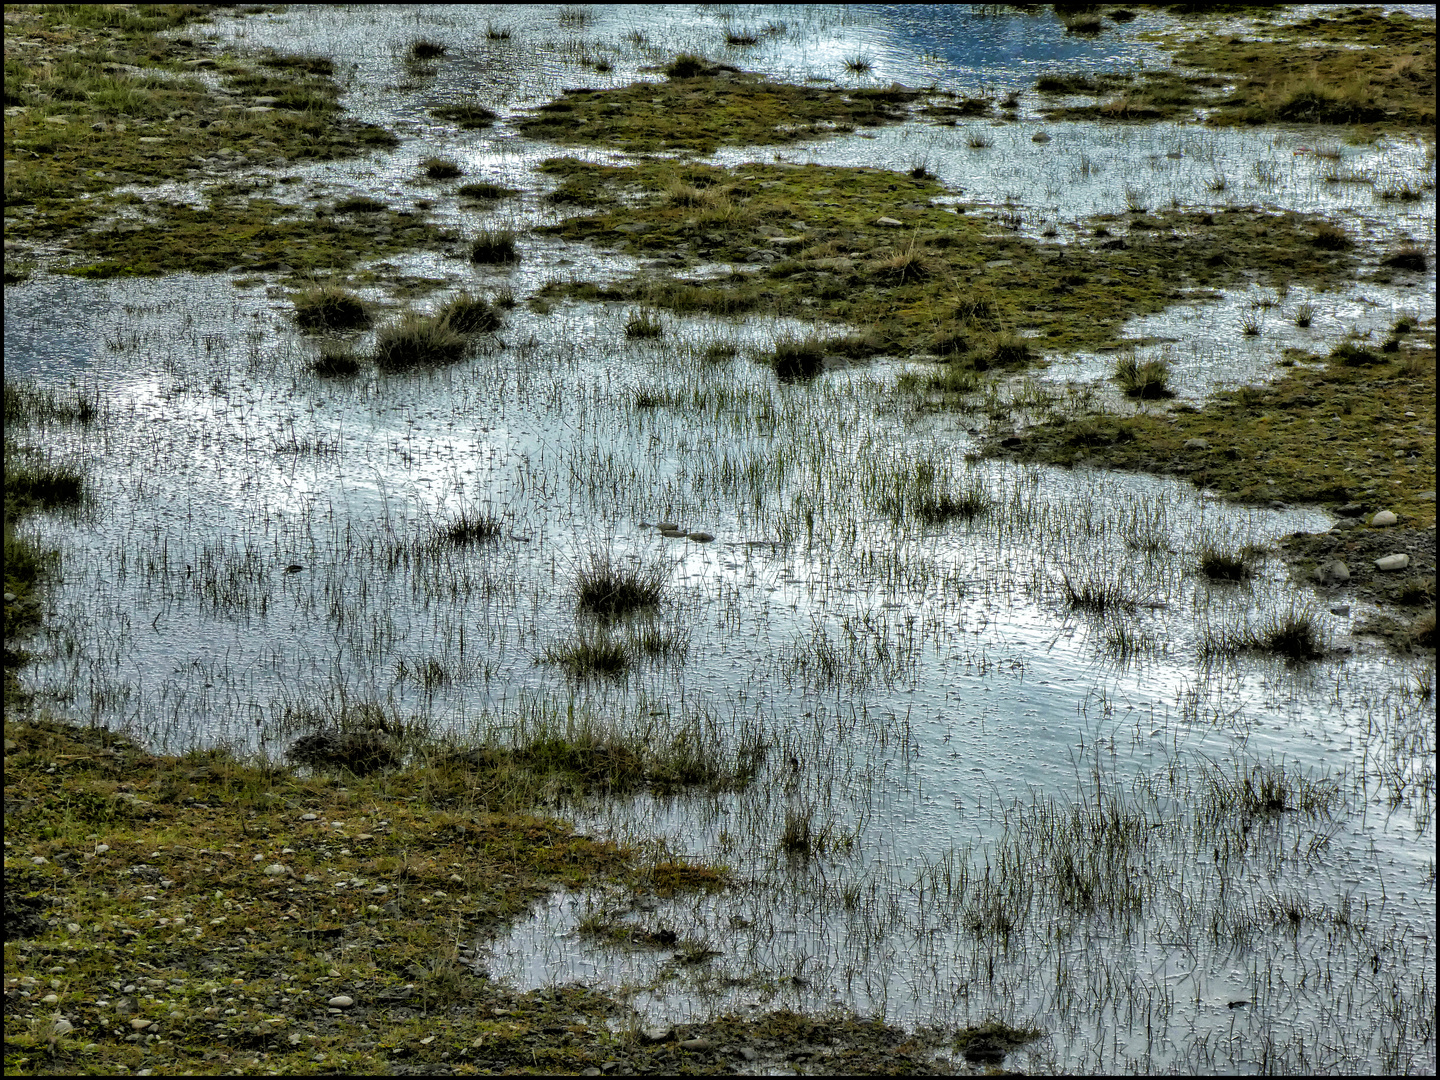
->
[518,66,920,154]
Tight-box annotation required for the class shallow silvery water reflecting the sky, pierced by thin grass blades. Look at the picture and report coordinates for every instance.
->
[6,7,1434,1071]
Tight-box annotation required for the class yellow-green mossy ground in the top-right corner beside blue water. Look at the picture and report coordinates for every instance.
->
[1037,6,1436,131]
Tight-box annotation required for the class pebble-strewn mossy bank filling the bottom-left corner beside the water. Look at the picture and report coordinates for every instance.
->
[4,719,984,1076]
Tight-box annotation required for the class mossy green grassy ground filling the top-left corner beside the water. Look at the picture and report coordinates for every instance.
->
[4,4,406,276]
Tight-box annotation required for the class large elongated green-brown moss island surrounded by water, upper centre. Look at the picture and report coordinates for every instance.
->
[541,158,1355,370]
